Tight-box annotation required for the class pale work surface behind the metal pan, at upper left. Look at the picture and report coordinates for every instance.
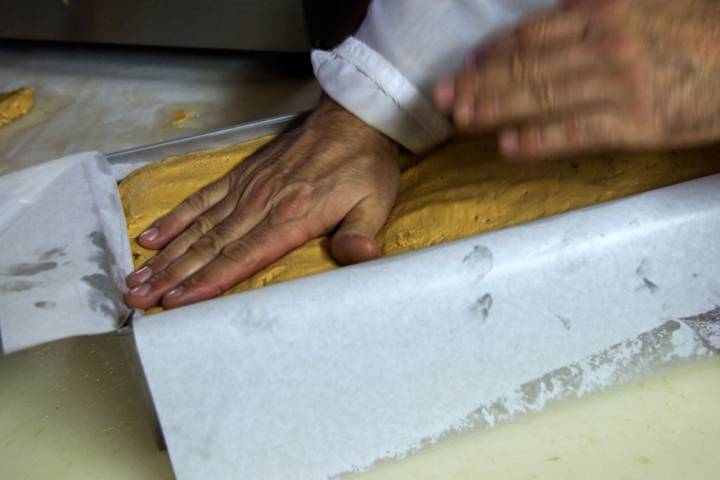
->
[0,42,320,173]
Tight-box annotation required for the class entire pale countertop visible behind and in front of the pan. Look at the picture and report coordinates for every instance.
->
[0,45,720,480]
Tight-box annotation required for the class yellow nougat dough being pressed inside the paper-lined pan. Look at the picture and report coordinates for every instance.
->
[120,138,720,293]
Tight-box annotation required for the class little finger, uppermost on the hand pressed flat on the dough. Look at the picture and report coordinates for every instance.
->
[138,175,230,250]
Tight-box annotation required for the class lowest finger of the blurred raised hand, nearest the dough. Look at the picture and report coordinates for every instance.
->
[499,112,628,161]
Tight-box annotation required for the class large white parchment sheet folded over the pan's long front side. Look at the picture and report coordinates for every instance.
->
[135,176,720,479]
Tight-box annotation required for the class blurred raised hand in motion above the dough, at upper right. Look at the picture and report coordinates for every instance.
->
[435,0,720,159]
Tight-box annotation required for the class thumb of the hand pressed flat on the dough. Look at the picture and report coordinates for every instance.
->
[330,197,390,265]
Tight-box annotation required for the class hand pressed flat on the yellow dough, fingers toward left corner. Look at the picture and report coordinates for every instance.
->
[125,100,399,309]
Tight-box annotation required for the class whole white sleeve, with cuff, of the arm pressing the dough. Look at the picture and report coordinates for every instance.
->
[312,0,555,153]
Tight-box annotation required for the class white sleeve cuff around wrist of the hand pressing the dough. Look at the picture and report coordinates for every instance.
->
[312,37,454,153]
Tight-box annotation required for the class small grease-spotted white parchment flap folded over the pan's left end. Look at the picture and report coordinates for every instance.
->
[0,153,132,353]
